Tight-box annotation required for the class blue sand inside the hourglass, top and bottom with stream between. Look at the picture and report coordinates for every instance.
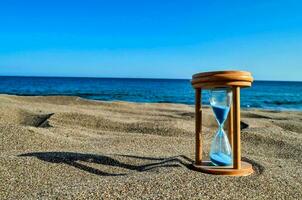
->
[210,105,232,166]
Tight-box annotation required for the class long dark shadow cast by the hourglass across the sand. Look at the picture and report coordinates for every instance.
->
[19,152,193,176]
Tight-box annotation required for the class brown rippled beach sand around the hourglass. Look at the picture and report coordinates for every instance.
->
[0,95,302,199]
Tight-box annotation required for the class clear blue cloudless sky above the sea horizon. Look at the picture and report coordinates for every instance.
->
[0,0,302,81]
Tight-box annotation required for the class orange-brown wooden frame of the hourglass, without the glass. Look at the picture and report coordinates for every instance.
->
[191,71,253,176]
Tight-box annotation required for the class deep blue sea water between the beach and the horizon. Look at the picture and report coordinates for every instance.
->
[0,77,302,111]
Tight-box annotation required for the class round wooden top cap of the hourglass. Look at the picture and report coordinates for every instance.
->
[191,71,254,88]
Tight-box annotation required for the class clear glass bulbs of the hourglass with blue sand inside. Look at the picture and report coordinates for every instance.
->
[209,88,233,166]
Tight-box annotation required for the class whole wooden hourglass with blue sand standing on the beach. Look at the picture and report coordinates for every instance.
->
[192,71,253,176]
